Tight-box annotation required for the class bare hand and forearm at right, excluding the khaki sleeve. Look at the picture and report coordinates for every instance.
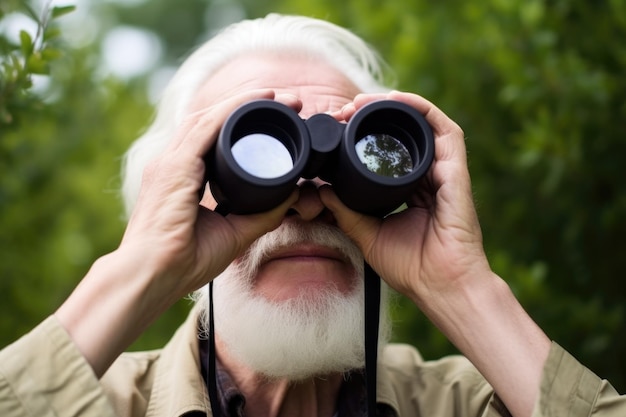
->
[322,92,550,416]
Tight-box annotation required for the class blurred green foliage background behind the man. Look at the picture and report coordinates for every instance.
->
[0,0,626,392]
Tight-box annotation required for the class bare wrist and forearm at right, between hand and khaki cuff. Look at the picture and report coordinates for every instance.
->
[412,271,550,415]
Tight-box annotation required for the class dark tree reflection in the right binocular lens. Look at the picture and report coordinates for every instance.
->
[355,133,413,178]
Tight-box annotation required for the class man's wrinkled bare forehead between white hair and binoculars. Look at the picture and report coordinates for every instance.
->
[191,53,360,117]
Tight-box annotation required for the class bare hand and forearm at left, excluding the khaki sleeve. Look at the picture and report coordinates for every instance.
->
[55,90,298,376]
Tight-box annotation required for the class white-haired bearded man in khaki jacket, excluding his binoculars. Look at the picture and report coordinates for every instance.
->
[0,15,626,417]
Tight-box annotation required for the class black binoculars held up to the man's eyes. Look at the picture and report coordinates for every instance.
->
[205,100,434,216]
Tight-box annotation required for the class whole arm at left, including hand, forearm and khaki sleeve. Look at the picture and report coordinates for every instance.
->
[0,90,300,417]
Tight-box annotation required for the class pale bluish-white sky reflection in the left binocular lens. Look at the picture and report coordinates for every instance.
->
[231,133,293,178]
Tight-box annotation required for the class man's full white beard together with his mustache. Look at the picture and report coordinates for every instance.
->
[199,222,391,381]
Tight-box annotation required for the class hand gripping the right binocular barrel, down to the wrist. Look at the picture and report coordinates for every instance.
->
[327,92,490,305]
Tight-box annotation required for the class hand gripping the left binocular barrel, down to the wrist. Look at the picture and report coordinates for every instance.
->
[120,90,299,302]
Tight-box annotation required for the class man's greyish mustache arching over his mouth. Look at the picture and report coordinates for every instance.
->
[236,220,364,284]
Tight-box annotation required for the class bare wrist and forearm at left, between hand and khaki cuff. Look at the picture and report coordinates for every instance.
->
[55,245,175,375]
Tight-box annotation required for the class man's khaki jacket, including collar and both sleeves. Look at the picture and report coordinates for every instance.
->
[0,314,626,417]
